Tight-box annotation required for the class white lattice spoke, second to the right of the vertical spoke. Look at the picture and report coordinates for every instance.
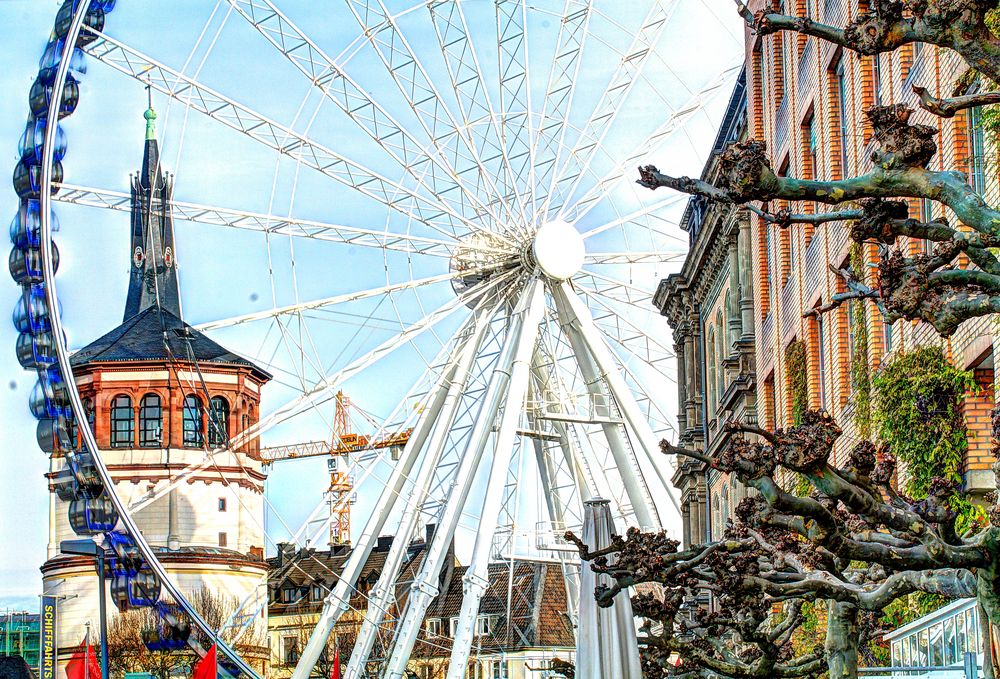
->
[553,0,680,216]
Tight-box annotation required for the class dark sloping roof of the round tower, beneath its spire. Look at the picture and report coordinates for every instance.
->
[70,306,271,379]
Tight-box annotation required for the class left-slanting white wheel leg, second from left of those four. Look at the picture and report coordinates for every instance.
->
[342,306,499,679]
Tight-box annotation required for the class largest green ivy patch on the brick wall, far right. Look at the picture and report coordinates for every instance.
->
[872,346,985,534]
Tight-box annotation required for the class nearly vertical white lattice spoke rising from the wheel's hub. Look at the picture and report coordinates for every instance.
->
[494,0,535,228]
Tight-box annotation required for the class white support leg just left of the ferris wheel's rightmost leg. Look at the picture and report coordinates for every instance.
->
[553,290,660,530]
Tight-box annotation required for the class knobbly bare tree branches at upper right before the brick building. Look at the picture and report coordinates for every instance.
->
[639,0,1000,336]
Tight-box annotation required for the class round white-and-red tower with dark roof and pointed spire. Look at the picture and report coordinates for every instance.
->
[41,106,271,671]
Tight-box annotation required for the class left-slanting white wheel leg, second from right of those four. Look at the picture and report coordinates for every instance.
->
[384,283,538,679]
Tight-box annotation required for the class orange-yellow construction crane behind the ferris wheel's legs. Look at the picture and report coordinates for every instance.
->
[260,391,413,546]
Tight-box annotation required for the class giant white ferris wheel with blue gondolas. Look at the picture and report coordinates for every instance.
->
[11,0,742,679]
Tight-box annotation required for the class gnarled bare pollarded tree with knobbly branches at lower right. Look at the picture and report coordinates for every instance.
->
[567,411,1000,679]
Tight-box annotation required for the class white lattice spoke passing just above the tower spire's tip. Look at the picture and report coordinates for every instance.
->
[84,32,480,244]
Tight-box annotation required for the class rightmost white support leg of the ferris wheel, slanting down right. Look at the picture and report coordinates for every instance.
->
[556,282,681,517]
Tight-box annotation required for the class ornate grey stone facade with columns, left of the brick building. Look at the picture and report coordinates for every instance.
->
[653,70,757,545]
